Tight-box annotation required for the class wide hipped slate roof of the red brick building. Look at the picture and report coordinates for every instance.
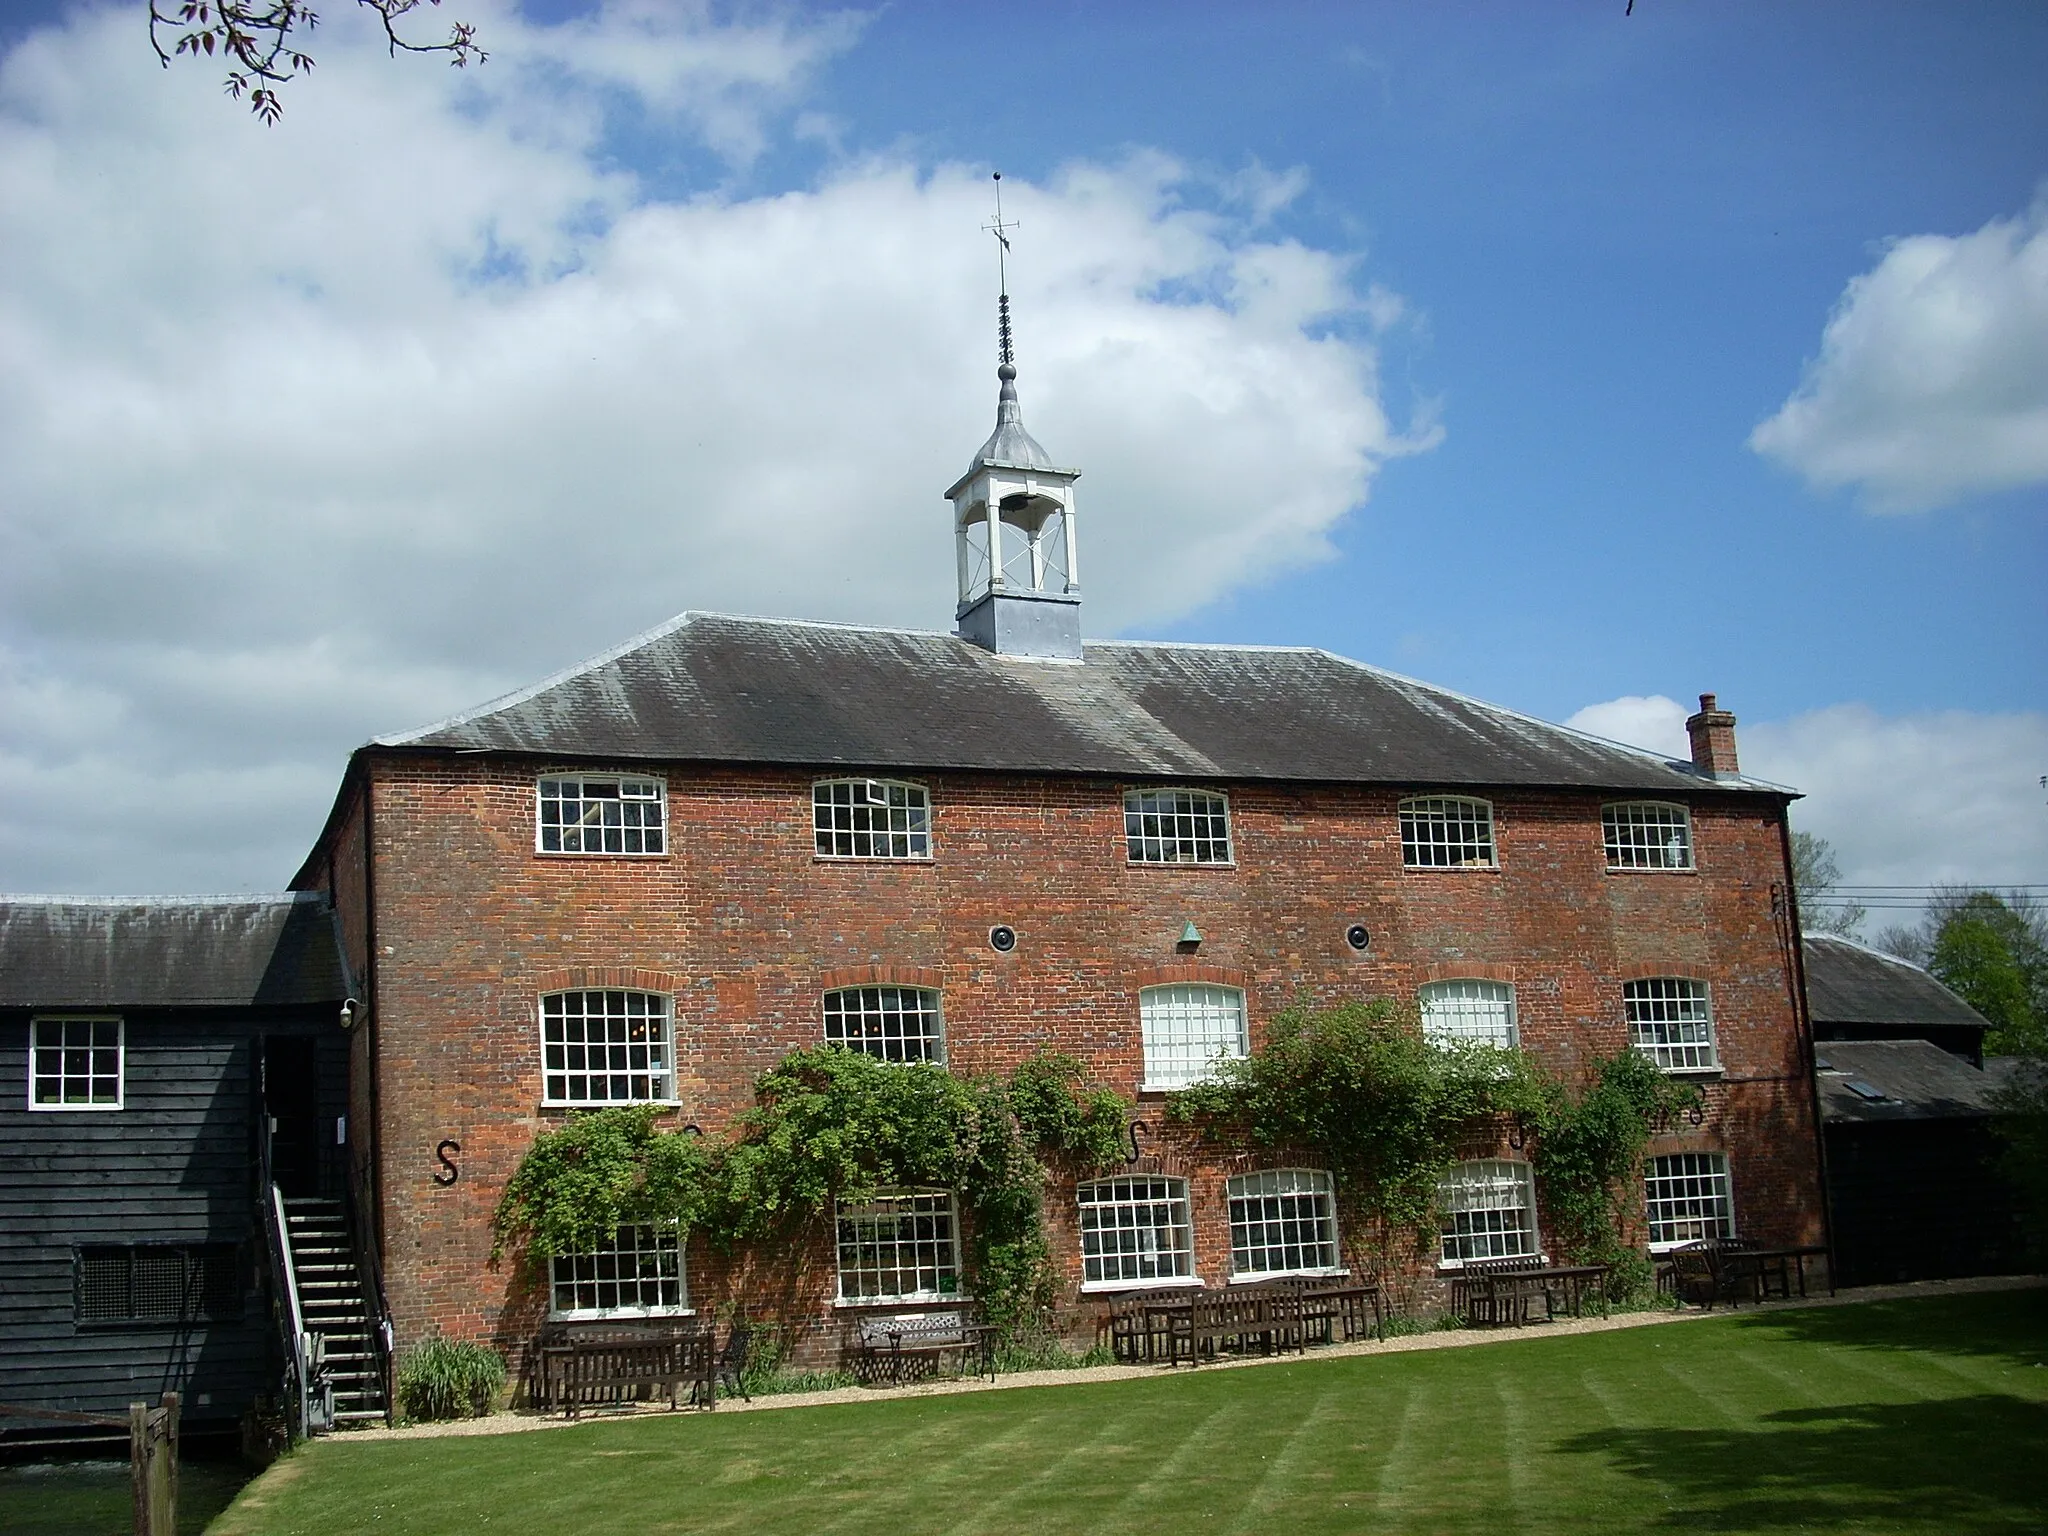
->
[371,612,1794,799]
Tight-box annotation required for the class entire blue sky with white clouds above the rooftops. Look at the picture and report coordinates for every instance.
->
[0,0,2048,909]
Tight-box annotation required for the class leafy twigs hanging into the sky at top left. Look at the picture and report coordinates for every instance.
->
[150,0,485,123]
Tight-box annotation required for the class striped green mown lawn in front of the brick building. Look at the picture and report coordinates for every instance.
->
[211,1290,2048,1536]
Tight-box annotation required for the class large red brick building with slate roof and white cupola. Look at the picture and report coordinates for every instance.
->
[295,354,1823,1368]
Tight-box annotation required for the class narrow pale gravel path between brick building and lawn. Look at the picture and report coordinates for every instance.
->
[338,1274,2048,1444]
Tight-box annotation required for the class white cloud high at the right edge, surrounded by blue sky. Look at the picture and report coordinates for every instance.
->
[1749,188,2048,512]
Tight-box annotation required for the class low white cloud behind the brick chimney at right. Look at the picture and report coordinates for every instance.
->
[1565,694,2048,885]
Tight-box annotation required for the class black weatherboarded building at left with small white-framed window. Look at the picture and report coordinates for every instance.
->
[0,895,350,1436]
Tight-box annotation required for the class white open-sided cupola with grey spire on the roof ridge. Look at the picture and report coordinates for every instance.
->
[946,293,1081,662]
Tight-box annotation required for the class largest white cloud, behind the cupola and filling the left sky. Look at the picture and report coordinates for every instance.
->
[0,4,1436,889]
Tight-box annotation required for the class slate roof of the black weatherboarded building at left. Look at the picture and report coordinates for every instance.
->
[0,893,348,1008]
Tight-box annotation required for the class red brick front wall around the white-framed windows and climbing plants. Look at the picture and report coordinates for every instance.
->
[342,754,1821,1368]
